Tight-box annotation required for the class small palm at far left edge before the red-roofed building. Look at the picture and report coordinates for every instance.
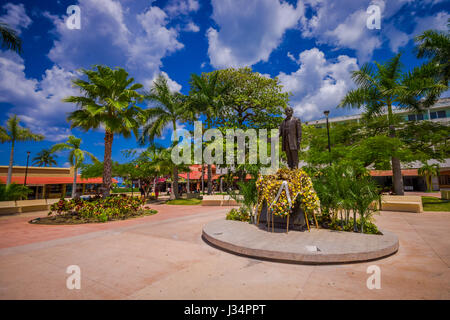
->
[0,115,44,186]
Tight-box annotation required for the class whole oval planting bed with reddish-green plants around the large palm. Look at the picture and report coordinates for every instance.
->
[30,196,157,224]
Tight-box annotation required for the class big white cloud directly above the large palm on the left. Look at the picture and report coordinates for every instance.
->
[49,0,183,82]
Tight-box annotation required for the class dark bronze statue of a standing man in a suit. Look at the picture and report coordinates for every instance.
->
[280,107,302,169]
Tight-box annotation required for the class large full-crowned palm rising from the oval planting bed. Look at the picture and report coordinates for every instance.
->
[64,65,142,196]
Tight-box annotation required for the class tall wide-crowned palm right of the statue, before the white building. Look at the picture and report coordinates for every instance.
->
[339,54,445,195]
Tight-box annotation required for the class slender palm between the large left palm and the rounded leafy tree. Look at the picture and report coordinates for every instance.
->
[140,75,189,199]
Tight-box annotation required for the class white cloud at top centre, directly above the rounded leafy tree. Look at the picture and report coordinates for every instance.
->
[207,0,303,68]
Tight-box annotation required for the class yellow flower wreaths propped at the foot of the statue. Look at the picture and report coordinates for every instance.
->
[256,168,319,217]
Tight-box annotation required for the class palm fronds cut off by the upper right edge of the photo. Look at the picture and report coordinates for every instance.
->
[414,24,450,85]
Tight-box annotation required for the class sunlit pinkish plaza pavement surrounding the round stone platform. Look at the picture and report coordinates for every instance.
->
[0,205,450,299]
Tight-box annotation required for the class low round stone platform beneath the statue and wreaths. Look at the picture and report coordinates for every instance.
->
[203,220,398,264]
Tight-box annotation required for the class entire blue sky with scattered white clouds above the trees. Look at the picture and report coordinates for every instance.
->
[0,0,450,166]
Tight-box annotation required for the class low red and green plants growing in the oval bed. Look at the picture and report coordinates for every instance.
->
[49,196,145,222]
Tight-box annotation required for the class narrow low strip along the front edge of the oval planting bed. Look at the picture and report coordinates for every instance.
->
[29,209,158,225]
